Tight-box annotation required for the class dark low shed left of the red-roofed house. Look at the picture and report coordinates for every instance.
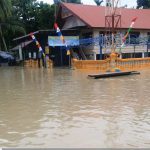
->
[11,29,78,67]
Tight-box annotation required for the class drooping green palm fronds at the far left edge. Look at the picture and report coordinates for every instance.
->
[0,0,25,51]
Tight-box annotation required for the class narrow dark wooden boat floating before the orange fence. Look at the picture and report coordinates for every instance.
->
[88,71,140,79]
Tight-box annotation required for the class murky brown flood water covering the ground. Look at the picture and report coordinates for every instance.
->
[0,67,150,148]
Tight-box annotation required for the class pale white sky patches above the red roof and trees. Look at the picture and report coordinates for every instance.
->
[39,0,136,8]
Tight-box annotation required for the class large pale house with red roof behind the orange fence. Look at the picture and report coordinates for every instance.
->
[57,3,150,60]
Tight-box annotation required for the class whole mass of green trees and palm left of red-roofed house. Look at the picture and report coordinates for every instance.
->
[0,0,55,50]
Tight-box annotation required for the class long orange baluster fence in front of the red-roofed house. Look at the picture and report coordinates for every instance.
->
[72,58,150,72]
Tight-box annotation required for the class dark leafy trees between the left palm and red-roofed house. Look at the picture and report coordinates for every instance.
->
[12,0,54,33]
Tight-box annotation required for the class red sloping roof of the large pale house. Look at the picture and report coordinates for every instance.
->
[61,3,150,29]
